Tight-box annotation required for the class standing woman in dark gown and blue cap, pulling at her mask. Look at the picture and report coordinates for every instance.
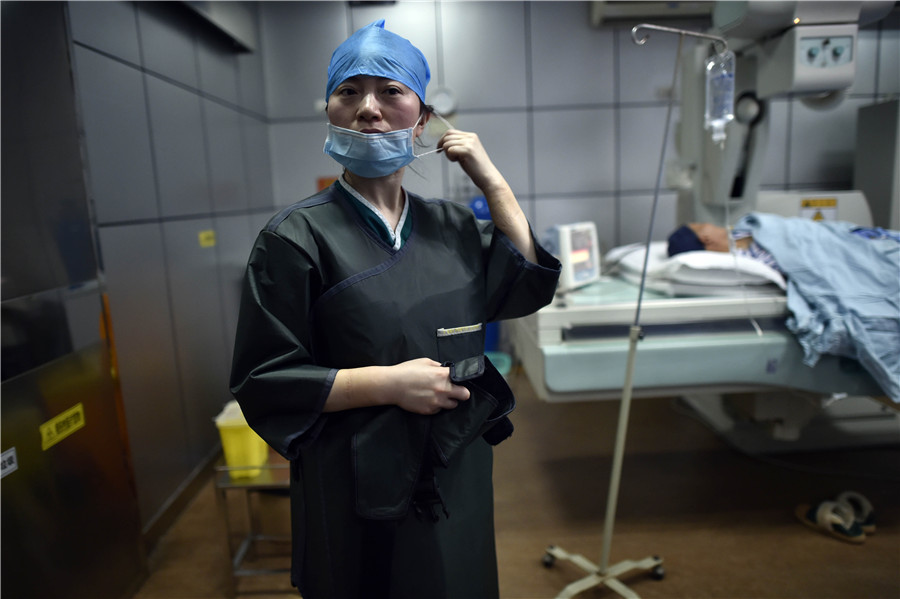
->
[231,21,560,599]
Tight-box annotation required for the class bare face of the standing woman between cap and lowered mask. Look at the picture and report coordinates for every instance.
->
[325,75,425,137]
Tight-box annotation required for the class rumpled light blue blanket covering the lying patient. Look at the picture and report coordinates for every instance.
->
[735,213,900,403]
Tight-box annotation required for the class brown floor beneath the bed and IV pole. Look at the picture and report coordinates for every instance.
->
[136,372,900,599]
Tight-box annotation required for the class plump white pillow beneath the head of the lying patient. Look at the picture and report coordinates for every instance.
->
[606,241,786,289]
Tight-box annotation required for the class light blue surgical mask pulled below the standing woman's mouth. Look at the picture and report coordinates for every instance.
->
[324,123,416,178]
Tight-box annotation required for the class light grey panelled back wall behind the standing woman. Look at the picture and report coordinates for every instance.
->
[262,0,900,248]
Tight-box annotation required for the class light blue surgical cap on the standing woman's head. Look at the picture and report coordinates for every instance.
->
[325,19,431,102]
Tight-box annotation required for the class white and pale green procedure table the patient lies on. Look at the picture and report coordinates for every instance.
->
[509,192,900,452]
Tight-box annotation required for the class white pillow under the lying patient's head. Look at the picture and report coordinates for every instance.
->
[604,241,786,296]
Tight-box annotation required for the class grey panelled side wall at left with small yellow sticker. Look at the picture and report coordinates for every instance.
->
[67,2,274,526]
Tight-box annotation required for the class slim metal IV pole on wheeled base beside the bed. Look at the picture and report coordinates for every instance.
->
[543,23,728,599]
